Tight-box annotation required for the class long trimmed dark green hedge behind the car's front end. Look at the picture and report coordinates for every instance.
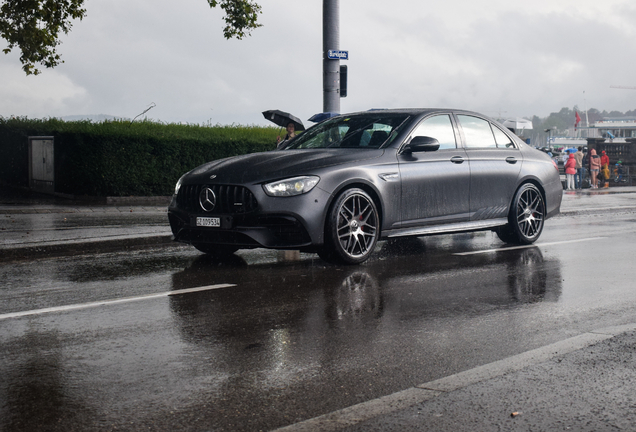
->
[0,117,279,196]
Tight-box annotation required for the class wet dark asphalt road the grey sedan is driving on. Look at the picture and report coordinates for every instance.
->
[0,211,636,431]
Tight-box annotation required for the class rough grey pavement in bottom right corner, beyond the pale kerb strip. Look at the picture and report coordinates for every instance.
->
[284,324,636,432]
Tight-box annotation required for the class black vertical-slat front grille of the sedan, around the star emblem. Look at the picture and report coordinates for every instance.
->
[177,185,258,215]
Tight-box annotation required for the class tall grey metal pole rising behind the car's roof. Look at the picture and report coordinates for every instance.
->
[322,0,340,113]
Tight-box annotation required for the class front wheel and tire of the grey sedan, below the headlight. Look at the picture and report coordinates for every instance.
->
[319,188,380,264]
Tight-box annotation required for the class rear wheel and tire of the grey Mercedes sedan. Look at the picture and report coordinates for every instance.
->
[497,183,545,245]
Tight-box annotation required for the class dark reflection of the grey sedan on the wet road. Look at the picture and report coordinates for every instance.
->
[170,235,562,424]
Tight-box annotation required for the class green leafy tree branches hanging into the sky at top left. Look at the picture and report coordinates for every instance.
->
[0,0,261,75]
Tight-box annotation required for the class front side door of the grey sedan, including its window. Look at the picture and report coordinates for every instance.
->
[398,114,470,228]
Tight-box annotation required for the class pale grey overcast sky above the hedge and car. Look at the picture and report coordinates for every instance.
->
[0,0,636,125]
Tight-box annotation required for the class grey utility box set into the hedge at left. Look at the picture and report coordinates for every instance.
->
[29,137,55,193]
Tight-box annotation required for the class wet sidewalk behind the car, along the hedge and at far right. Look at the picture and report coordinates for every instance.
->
[0,187,636,262]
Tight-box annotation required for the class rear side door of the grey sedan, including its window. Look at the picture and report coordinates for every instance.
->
[456,114,523,220]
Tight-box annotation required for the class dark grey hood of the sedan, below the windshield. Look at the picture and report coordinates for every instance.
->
[183,149,384,184]
